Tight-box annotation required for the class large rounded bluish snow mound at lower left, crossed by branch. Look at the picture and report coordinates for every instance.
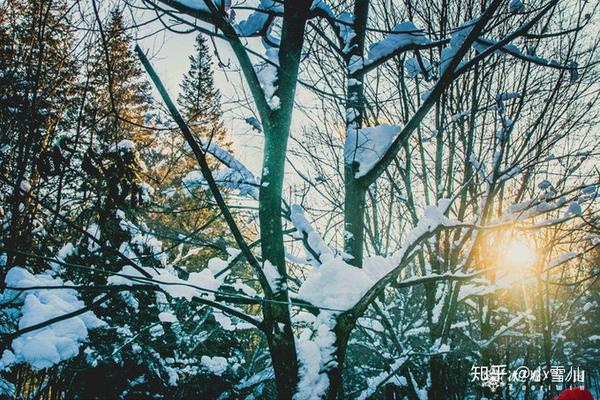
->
[2,267,105,370]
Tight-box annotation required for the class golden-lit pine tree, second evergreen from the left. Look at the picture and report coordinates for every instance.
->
[82,9,153,224]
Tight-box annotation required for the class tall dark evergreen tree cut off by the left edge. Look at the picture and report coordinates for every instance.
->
[0,1,76,276]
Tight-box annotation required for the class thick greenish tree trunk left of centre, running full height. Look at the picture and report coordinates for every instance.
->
[258,0,311,399]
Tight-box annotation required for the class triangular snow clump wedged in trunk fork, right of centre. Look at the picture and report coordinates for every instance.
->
[344,124,400,178]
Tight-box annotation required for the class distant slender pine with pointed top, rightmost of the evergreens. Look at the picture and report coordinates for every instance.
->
[146,35,236,265]
